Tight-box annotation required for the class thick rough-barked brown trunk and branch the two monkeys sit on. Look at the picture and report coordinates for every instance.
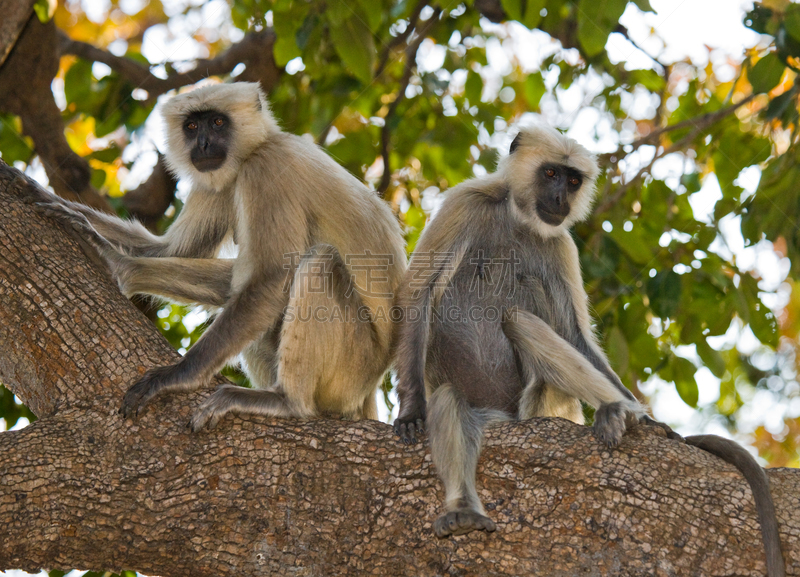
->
[0,163,800,577]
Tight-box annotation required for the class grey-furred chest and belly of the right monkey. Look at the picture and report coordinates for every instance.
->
[426,191,578,416]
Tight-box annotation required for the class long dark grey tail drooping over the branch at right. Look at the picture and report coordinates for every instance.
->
[685,435,786,577]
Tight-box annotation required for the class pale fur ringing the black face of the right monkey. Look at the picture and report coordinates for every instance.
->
[497,125,600,237]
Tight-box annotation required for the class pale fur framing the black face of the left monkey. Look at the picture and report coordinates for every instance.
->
[161,82,280,191]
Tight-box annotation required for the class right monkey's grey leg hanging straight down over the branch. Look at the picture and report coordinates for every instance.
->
[427,384,507,537]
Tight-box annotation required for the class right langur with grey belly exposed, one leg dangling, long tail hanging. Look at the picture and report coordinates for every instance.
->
[394,126,783,575]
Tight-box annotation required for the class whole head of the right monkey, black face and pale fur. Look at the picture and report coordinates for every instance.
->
[498,125,600,237]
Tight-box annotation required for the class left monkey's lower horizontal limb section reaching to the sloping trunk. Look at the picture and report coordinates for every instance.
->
[109,256,234,307]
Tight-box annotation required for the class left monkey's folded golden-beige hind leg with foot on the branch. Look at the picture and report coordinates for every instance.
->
[192,245,388,431]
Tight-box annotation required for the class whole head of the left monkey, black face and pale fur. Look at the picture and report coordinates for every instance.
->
[162,82,279,190]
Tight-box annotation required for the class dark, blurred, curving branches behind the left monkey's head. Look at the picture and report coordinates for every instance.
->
[0,16,281,224]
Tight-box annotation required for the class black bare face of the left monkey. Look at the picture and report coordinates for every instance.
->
[188,110,233,172]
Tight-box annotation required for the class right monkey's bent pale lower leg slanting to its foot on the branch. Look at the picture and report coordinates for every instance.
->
[503,308,644,447]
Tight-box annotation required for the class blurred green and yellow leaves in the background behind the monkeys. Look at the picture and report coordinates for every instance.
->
[0,0,800,463]
